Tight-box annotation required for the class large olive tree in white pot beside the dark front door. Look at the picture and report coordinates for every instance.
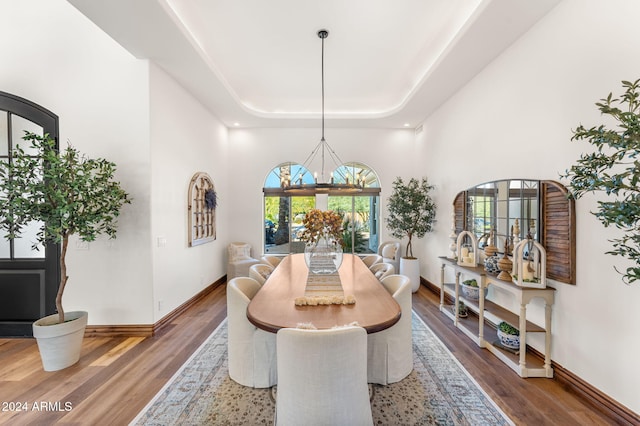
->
[0,132,131,371]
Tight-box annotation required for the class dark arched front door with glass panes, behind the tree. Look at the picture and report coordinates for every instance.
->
[0,92,60,337]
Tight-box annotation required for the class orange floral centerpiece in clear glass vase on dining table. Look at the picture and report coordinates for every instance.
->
[300,209,344,274]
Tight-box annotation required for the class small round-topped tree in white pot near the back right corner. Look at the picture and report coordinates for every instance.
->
[386,177,436,292]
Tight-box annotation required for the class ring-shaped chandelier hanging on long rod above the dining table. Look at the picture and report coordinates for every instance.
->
[280,30,365,195]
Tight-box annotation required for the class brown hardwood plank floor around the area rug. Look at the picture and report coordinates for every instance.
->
[0,285,616,425]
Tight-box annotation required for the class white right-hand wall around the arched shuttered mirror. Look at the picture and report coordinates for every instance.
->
[417,0,640,412]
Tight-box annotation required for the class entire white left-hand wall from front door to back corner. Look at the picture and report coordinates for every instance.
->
[0,0,231,325]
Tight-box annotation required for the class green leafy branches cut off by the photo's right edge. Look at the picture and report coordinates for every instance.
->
[563,80,640,284]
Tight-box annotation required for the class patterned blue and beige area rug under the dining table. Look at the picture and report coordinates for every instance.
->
[131,312,513,426]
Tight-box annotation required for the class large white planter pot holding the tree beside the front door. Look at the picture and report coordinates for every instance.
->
[33,311,88,371]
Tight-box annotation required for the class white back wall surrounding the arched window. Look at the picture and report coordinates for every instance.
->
[228,126,416,253]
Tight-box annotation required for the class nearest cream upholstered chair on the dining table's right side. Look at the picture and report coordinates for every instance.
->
[367,275,413,385]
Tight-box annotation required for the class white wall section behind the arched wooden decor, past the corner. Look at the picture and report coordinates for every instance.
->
[150,66,233,322]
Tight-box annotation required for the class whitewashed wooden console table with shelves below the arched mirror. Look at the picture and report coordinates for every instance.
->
[440,257,555,378]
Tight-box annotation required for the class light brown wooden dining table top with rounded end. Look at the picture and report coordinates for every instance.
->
[247,253,401,333]
